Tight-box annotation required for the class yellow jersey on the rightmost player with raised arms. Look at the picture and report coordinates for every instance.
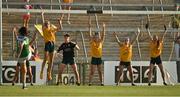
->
[150,41,163,58]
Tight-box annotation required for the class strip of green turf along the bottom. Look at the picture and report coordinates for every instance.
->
[0,85,180,97]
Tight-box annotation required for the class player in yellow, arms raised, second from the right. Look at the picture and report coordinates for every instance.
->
[114,28,140,86]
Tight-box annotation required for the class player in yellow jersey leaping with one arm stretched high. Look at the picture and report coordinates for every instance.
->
[40,12,62,80]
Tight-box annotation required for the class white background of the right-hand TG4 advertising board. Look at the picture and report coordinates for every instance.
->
[104,61,177,85]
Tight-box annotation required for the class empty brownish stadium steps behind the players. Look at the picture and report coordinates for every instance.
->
[2,0,175,83]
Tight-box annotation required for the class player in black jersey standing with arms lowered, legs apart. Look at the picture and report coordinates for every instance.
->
[57,34,80,85]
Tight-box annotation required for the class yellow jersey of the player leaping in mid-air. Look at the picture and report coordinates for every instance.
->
[43,27,56,43]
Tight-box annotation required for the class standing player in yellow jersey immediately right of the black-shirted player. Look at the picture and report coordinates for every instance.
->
[89,17,105,86]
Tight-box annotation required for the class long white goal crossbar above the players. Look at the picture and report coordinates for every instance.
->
[2,8,180,15]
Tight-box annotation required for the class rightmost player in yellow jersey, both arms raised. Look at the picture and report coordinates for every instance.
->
[146,26,167,86]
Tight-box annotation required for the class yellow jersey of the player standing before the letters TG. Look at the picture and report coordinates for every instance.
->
[120,44,132,62]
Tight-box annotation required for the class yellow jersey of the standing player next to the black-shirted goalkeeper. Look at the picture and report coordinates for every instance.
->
[90,41,102,58]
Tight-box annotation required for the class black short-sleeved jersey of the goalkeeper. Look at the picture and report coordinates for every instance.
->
[57,42,76,59]
